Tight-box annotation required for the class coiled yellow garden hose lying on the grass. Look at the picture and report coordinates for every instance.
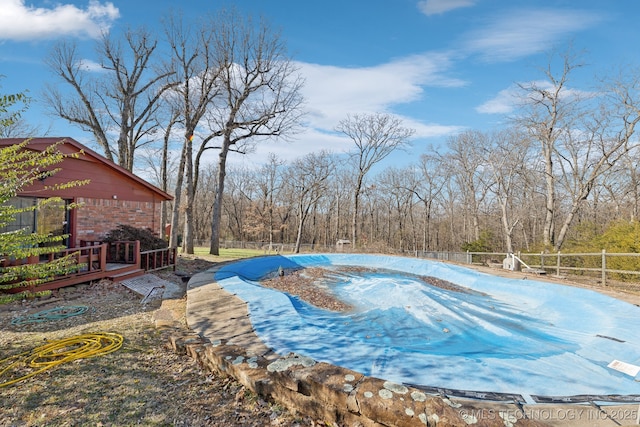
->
[0,332,124,387]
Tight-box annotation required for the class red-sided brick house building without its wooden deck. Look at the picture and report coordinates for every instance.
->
[0,138,172,248]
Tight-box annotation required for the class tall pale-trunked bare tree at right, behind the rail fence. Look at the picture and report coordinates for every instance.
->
[517,50,640,251]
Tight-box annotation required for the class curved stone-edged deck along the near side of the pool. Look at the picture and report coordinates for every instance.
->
[172,260,640,427]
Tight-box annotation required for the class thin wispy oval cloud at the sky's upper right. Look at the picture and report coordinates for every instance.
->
[465,9,602,61]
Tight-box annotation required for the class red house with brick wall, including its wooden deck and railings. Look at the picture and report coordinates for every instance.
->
[0,138,176,291]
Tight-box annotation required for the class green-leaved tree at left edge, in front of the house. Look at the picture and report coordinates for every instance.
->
[0,89,86,297]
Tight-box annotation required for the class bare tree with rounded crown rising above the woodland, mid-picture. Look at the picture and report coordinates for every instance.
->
[336,113,414,248]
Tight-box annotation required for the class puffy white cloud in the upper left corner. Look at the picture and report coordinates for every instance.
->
[0,0,120,41]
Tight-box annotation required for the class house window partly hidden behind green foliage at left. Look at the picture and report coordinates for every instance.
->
[0,197,70,246]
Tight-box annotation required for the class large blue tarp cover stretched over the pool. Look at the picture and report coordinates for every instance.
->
[215,254,640,400]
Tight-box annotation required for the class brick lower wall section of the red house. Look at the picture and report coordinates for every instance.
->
[75,197,161,245]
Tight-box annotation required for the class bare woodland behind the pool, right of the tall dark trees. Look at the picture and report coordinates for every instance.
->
[158,54,640,252]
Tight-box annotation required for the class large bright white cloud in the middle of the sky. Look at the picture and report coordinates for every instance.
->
[220,54,465,166]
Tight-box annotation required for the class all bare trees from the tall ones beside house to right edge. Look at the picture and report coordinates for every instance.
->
[44,11,640,254]
